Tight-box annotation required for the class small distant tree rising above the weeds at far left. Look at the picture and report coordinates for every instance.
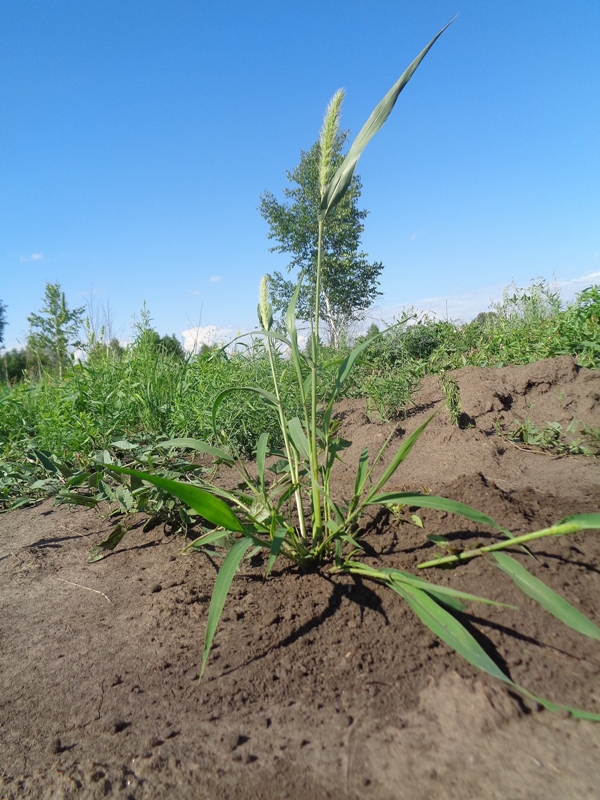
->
[27,283,85,378]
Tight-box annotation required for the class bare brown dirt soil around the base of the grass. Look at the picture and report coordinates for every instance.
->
[0,357,600,800]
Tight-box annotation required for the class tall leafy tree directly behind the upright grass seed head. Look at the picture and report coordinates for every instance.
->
[259,131,383,347]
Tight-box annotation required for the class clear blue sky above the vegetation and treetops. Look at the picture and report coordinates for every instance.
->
[0,0,600,347]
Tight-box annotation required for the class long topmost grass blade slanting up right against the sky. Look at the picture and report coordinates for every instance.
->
[319,20,454,220]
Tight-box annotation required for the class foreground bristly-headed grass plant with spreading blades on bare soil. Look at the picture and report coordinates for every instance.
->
[89,20,600,720]
